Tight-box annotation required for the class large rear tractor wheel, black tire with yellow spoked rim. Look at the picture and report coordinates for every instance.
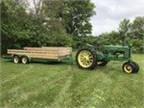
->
[76,49,96,69]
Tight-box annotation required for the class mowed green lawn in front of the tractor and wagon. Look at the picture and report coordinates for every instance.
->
[0,54,144,108]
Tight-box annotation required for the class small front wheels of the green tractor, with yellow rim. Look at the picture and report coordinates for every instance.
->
[122,62,139,74]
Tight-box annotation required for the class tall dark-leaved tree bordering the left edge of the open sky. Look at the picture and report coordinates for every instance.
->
[61,0,95,36]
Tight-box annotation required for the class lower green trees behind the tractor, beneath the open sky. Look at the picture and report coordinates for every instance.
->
[85,16,144,53]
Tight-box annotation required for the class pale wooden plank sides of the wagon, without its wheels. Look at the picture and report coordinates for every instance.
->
[7,47,72,59]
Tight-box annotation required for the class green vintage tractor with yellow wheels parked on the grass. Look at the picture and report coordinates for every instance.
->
[76,45,139,73]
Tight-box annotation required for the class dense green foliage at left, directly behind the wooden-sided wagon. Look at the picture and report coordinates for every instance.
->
[1,0,72,53]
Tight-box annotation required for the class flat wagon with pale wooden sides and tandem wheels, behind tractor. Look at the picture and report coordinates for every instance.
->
[7,47,72,64]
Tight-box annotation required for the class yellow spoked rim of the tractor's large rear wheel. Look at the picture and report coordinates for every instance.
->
[78,50,93,68]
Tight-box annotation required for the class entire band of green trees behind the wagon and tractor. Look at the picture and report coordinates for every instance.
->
[0,0,144,53]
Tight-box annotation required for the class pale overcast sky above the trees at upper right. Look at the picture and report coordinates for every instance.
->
[91,0,144,35]
